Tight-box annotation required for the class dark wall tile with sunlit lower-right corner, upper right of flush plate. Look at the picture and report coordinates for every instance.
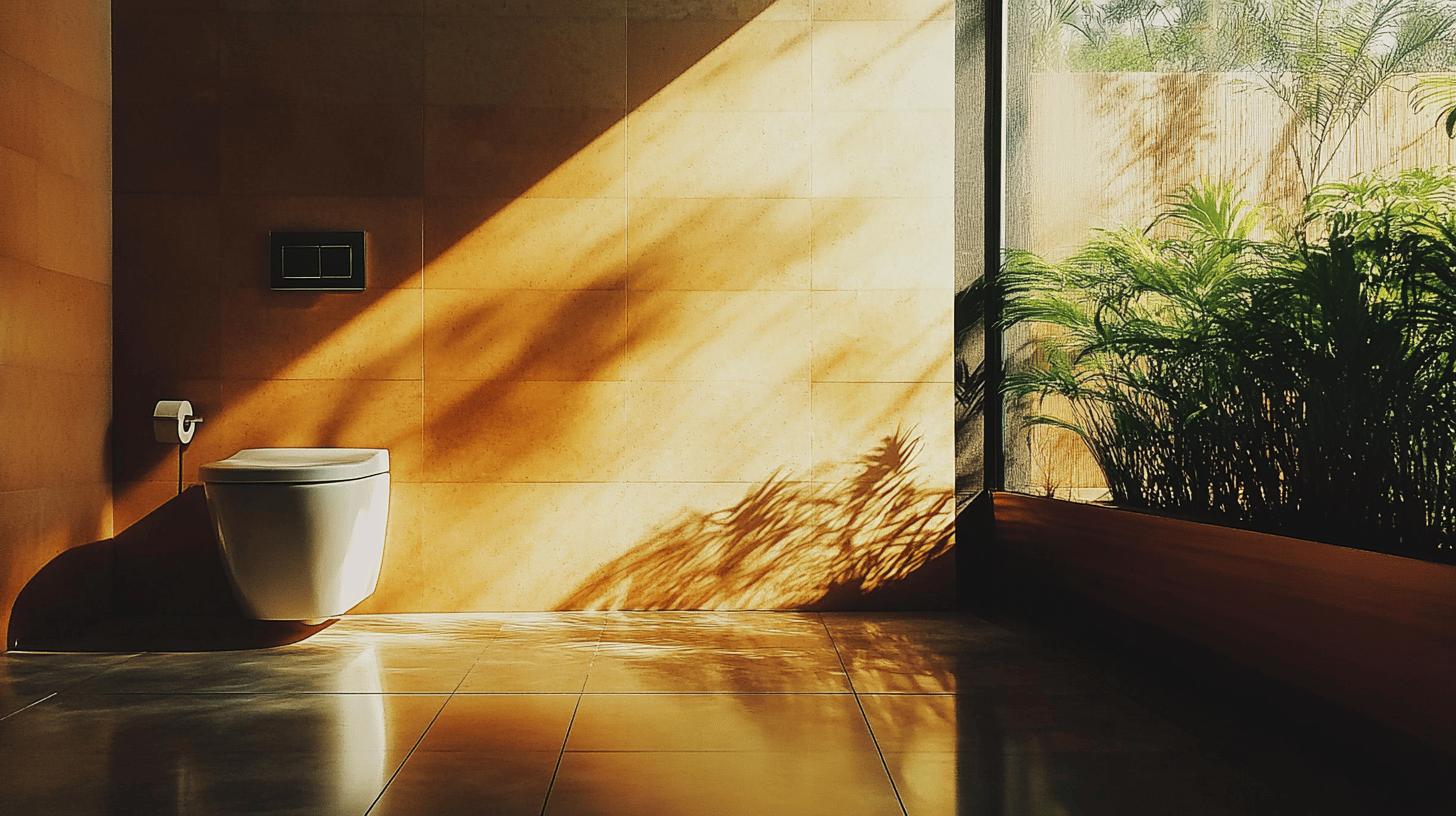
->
[425,106,626,198]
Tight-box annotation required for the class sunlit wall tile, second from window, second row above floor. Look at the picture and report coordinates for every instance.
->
[626,382,810,481]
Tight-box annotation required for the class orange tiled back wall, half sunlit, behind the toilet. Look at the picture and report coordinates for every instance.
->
[115,0,954,611]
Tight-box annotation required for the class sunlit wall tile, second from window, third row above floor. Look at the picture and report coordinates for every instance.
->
[626,291,810,383]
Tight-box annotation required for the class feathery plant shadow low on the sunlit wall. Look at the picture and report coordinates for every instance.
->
[559,428,952,609]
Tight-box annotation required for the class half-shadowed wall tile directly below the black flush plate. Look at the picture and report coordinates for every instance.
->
[221,289,424,379]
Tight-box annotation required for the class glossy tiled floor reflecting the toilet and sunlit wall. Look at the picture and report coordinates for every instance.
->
[0,612,1450,816]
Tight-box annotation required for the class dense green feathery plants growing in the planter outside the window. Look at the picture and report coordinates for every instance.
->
[999,172,1456,561]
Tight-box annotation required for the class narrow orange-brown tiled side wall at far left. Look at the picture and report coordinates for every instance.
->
[0,0,111,648]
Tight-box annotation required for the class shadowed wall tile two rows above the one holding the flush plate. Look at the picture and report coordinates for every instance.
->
[221,15,425,105]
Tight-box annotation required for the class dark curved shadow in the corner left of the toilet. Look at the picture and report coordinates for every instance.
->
[6,487,332,651]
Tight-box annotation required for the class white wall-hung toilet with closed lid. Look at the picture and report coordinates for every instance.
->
[201,447,389,621]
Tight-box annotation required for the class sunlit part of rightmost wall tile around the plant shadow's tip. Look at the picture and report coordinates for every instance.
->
[812,382,955,490]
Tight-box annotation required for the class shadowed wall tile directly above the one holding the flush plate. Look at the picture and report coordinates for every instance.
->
[221,103,422,195]
